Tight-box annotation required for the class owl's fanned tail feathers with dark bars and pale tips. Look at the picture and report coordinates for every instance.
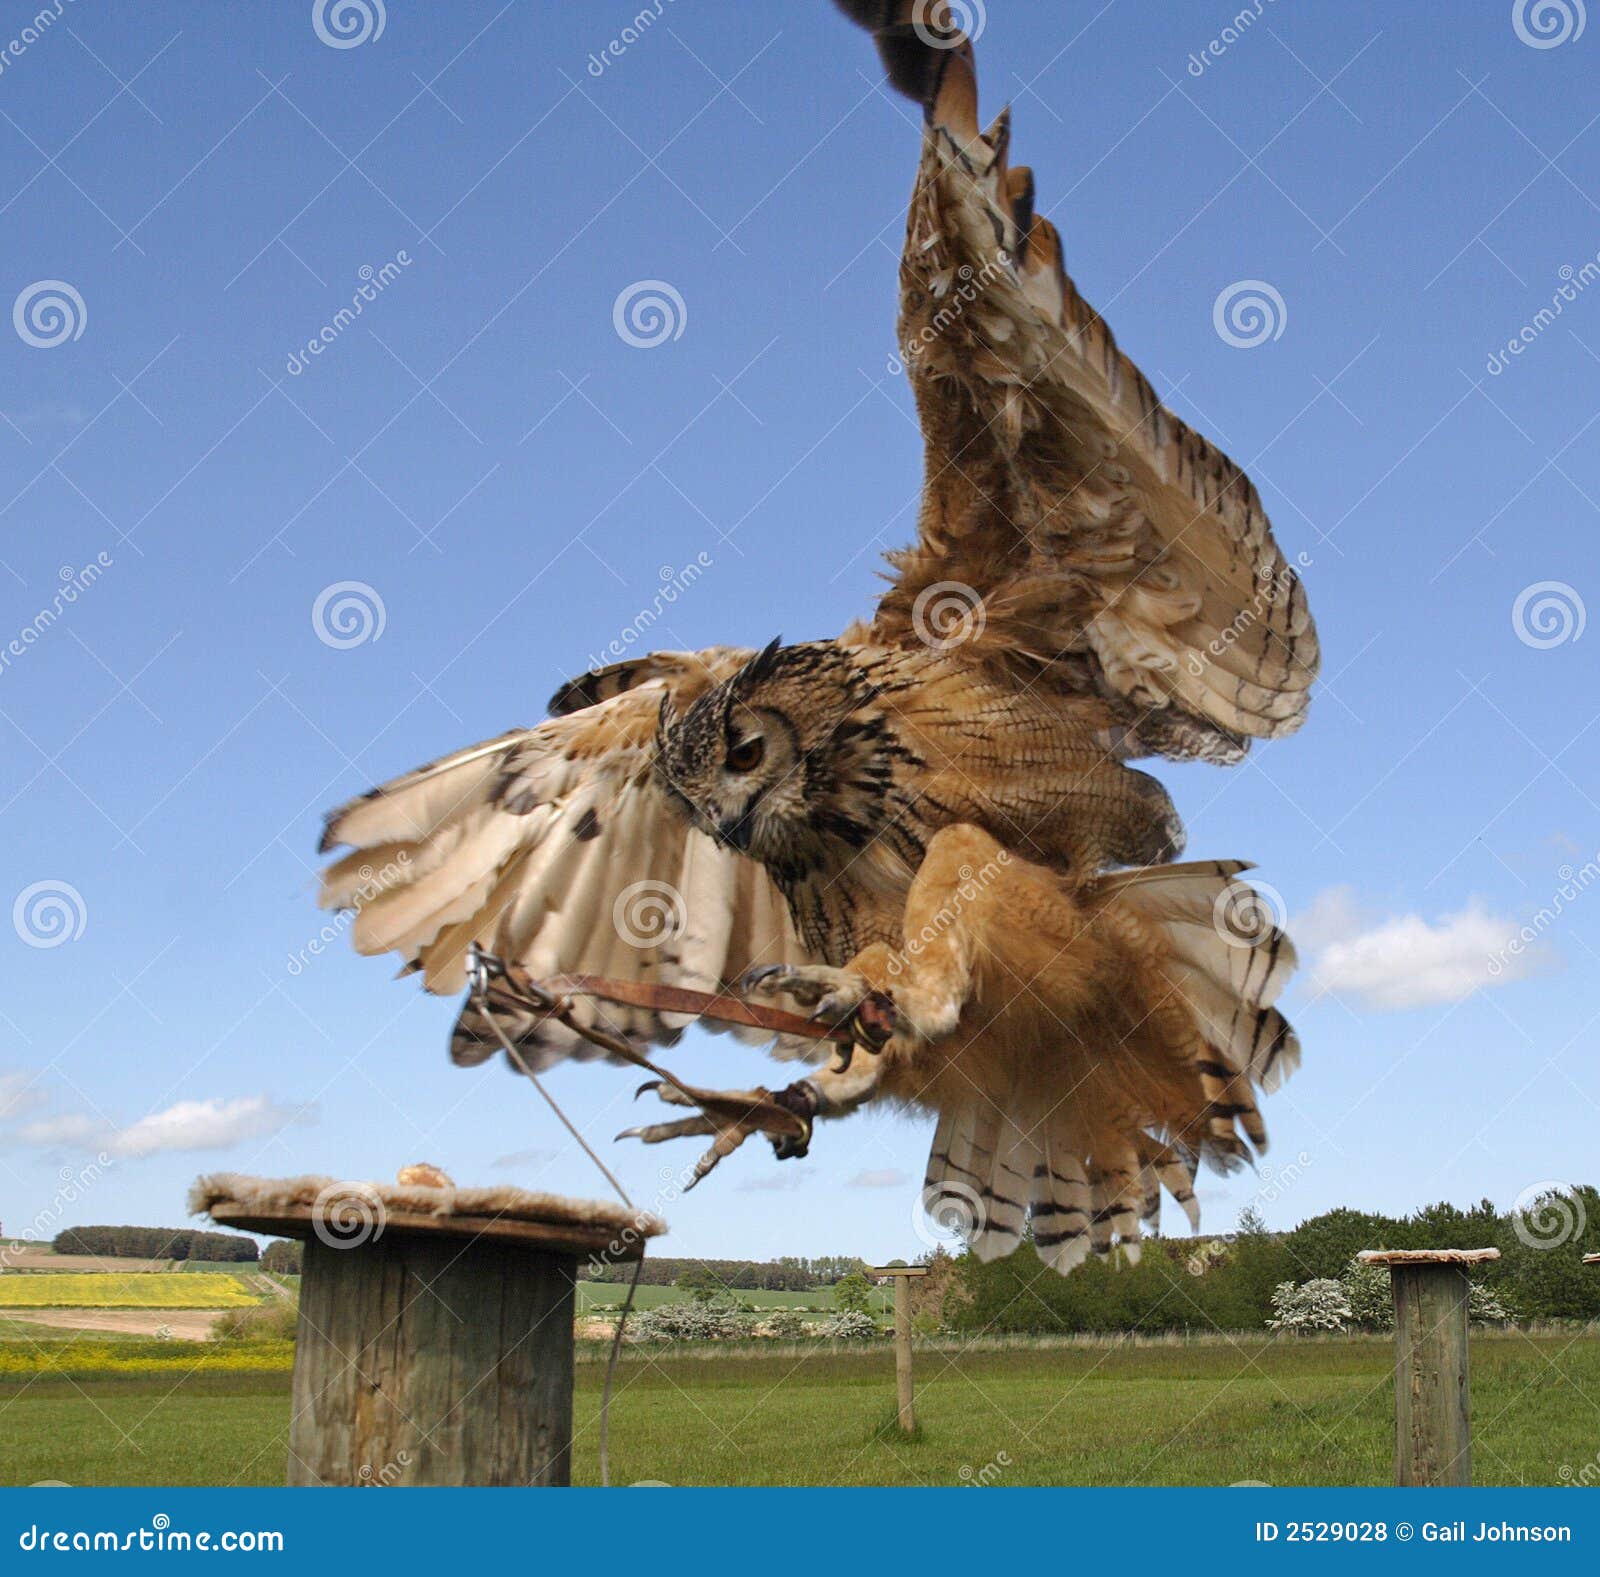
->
[923,860,1299,1275]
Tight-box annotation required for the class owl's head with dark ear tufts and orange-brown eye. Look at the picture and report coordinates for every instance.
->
[656,641,904,873]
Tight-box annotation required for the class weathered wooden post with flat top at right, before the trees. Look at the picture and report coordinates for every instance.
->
[1357,1249,1499,1487]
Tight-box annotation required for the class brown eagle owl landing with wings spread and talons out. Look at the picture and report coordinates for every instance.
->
[312,0,1317,1272]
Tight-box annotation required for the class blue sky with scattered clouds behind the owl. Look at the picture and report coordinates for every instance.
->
[0,0,1600,1257]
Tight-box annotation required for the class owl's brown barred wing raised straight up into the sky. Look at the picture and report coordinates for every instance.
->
[838,0,1318,760]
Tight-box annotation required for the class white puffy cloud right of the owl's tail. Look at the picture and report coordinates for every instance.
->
[1290,888,1547,1009]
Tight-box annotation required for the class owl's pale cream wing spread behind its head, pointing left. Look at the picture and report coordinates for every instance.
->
[322,651,814,1068]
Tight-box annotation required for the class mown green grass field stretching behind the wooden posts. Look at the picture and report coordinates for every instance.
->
[0,1335,1600,1486]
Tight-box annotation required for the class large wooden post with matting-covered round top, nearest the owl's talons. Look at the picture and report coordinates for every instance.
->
[190,1176,662,1486]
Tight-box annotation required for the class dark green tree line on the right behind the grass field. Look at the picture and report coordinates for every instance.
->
[936,1185,1600,1332]
